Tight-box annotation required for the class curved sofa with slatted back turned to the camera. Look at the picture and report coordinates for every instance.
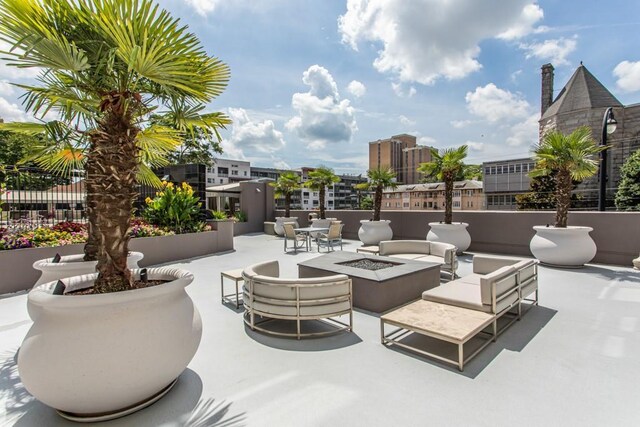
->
[242,261,353,339]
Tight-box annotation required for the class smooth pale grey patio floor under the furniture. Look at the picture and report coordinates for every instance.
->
[0,234,640,426]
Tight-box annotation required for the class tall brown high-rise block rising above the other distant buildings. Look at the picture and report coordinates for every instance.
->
[369,133,431,184]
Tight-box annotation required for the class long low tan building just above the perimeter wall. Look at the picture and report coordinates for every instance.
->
[382,180,485,211]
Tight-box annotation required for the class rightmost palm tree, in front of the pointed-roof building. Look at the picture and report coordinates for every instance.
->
[529,126,607,228]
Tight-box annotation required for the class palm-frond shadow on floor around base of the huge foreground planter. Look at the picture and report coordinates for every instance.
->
[0,351,246,427]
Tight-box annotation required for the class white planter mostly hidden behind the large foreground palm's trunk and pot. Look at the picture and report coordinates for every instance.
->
[33,252,144,286]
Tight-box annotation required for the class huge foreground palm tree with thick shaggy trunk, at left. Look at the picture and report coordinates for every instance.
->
[0,0,229,293]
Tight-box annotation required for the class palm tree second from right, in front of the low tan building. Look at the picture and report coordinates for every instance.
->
[418,145,467,224]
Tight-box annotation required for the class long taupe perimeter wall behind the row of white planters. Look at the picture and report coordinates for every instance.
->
[275,210,640,267]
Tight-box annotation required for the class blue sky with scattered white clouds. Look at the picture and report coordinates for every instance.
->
[0,0,640,174]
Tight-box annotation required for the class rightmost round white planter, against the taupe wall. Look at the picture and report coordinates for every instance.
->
[529,225,597,267]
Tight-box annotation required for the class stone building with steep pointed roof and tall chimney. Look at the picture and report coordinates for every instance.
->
[539,64,640,208]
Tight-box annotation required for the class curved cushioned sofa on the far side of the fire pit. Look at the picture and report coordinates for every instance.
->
[378,240,458,279]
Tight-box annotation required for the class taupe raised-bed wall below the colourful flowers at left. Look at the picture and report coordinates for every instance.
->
[0,229,233,295]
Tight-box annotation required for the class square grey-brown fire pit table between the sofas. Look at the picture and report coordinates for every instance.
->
[298,251,440,313]
